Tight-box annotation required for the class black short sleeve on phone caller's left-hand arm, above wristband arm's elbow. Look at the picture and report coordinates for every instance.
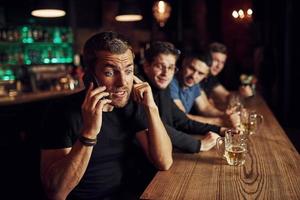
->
[40,101,72,149]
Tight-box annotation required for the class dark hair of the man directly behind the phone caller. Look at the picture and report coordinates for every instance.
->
[145,41,180,63]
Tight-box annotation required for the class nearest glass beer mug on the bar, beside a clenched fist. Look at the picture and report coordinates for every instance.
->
[217,129,247,166]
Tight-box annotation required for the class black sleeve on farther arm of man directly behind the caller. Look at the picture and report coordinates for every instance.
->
[172,102,220,134]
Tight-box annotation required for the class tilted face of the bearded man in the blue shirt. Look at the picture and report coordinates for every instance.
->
[180,59,209,87]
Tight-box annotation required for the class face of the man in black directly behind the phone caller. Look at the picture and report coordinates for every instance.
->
[144,54,176,89]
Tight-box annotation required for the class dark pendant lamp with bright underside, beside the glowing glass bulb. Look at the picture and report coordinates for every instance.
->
[115,0,143,22]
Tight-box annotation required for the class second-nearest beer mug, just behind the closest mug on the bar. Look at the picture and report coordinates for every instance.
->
[240,109,263,135]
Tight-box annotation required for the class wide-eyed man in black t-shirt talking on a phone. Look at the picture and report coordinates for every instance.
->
[41,32,173,200]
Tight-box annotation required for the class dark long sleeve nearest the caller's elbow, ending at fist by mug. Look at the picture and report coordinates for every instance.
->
[165,124,201,153]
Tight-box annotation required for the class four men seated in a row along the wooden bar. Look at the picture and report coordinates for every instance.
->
[41,32,254,200]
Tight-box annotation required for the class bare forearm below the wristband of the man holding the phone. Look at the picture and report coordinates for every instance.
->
[41,141,93,199]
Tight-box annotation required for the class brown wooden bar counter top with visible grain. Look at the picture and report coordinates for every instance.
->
[141,96,300,200]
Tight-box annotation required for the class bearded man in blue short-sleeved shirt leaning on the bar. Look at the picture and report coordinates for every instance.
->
[170,52,229,125]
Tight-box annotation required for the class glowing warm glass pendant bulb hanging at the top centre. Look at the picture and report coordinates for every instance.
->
[152,1,171,27]
